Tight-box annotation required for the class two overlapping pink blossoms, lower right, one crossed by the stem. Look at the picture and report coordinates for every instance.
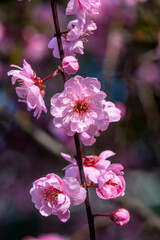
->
[61,150,125,199]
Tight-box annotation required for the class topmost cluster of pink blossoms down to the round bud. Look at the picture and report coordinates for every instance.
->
[48,0,100,75]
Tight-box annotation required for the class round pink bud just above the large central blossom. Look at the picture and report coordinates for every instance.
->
[62,56,80,75]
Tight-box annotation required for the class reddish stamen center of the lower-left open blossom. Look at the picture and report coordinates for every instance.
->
[43,186,61,203]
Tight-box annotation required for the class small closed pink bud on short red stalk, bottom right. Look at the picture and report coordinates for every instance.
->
[110,208,130,226]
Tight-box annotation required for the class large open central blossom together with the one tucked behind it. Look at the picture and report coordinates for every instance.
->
[51,75,120,145]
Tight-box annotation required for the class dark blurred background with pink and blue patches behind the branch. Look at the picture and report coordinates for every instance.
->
[0,0,160,240]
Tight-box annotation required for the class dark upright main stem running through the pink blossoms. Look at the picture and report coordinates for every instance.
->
[50,0,95,240]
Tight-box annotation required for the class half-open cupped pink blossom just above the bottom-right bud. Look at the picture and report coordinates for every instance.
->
[96,169,125,199]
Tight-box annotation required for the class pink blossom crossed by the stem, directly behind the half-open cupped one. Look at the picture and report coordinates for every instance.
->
[61,150,117,184]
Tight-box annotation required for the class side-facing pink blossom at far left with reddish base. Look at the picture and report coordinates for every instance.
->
[8,60,47,118]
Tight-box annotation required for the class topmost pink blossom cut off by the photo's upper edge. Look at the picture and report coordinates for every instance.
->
[66,0,100,20]
